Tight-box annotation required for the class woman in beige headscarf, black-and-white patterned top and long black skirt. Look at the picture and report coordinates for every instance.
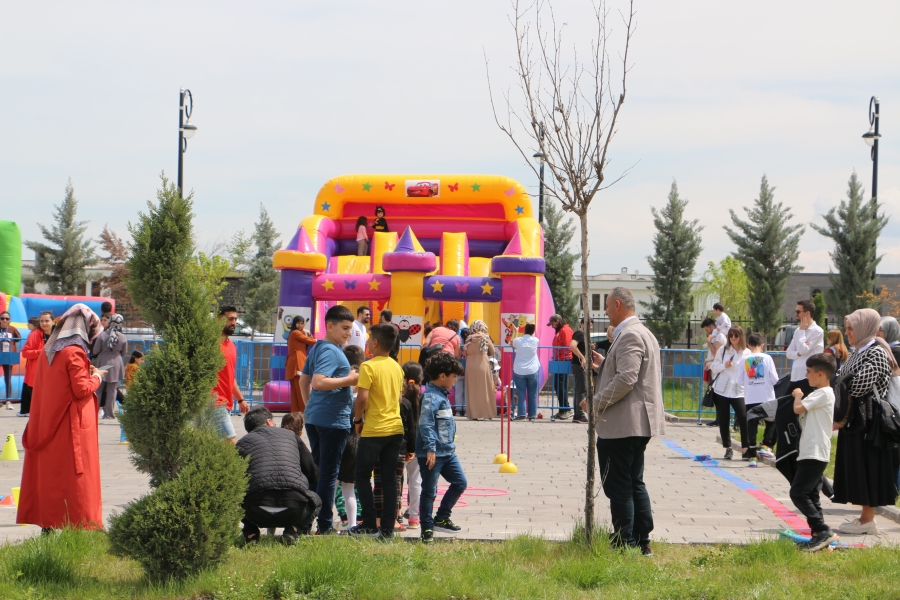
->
[832,308,898,535]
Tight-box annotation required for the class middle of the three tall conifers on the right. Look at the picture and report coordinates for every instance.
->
[725,175,804,337]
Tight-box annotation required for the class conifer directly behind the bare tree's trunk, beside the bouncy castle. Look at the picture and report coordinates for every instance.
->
[544,199,581,323]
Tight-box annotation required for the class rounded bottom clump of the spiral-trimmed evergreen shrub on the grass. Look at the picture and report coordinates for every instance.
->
[109,426,247,580]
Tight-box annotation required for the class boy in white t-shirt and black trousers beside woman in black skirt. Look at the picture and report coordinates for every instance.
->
[791,354,838,552]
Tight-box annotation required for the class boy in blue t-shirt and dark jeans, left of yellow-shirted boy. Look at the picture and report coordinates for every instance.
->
[300,306,359,535]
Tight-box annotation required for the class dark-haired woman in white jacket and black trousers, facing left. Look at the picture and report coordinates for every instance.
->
[709,325,750,460]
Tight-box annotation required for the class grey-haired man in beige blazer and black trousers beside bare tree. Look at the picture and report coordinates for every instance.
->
[584,287,665,556]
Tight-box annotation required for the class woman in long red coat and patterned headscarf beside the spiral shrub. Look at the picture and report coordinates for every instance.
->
[16,304,103,529]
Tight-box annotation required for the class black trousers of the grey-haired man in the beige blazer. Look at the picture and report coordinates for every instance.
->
[597,437,653,546]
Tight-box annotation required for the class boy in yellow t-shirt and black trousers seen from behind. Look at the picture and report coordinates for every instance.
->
[348,323,403,538]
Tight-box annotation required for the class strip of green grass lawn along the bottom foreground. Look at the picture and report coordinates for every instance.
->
[0,531,900,600]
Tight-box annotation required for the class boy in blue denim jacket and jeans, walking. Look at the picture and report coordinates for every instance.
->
[416,352,467,544]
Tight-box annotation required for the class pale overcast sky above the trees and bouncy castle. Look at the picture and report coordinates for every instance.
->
[0,0,900,273]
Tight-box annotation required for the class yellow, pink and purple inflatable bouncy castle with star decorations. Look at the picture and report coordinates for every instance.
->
[262,175,554,406]
